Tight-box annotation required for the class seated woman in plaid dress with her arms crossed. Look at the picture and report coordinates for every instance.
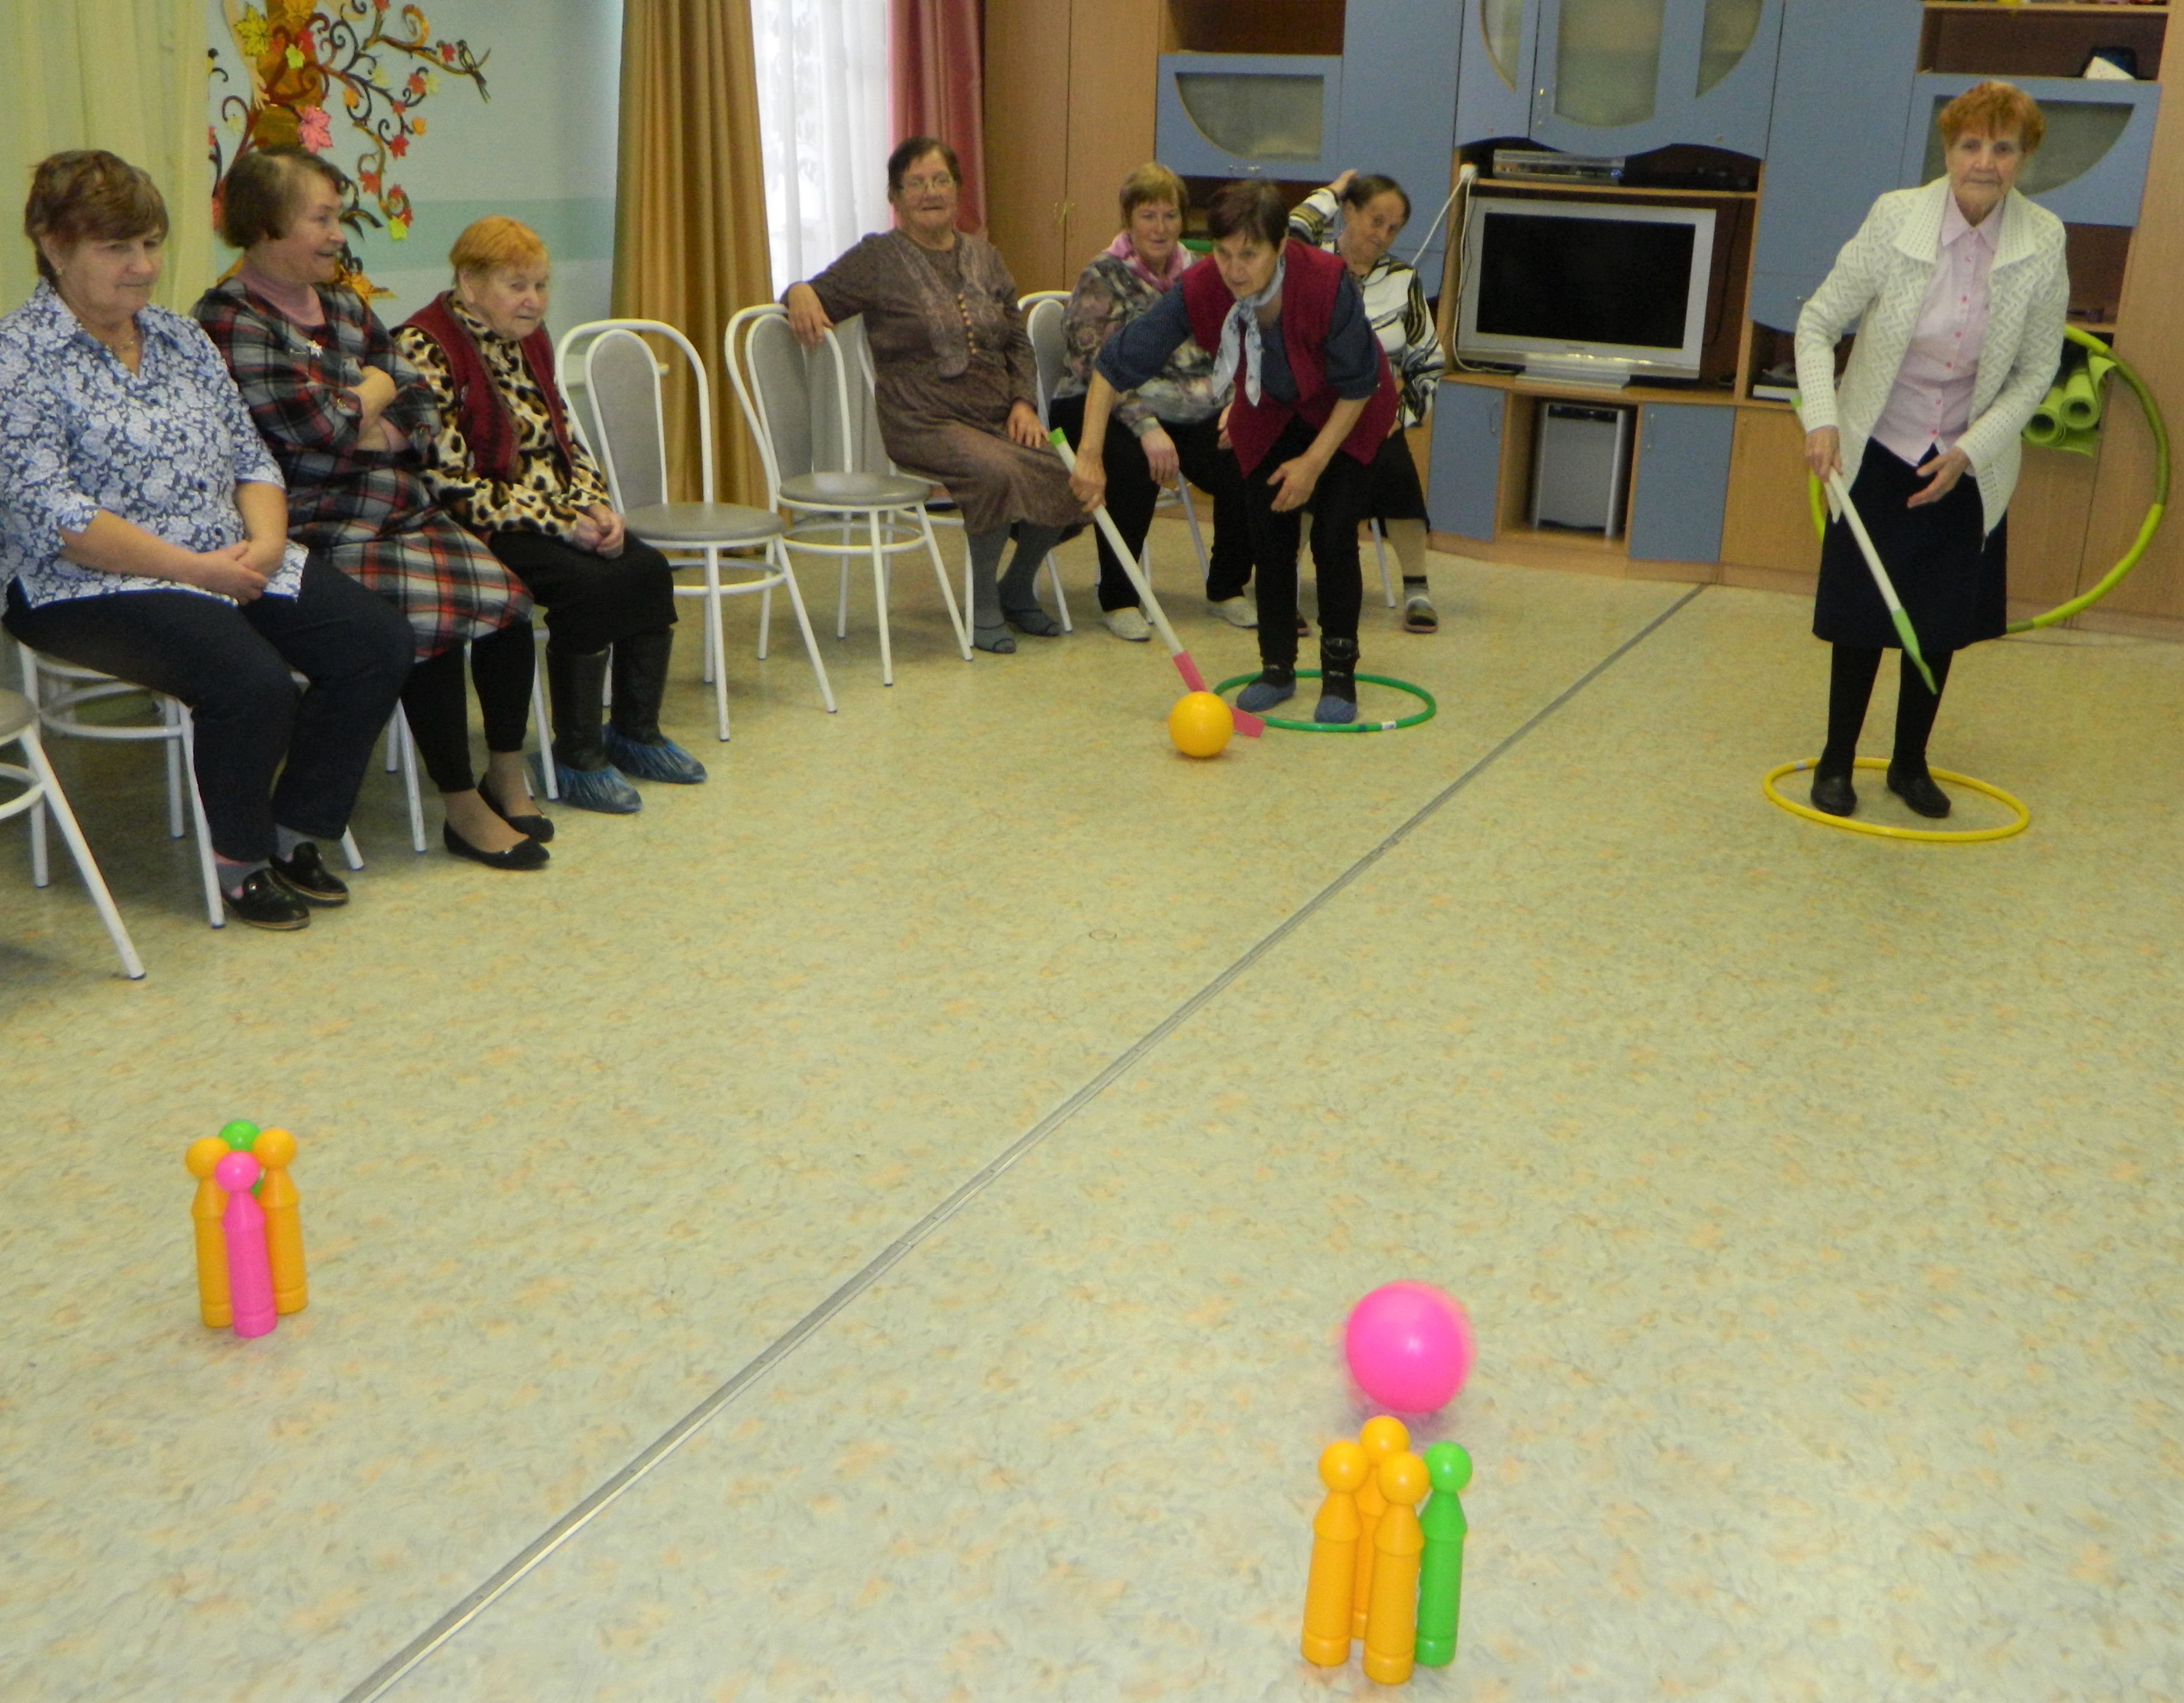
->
[197,146,552,869]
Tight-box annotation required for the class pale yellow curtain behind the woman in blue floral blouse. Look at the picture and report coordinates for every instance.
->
[0,0,214,312]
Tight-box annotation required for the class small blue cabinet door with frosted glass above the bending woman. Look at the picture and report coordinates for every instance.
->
[1153,53,1343,183]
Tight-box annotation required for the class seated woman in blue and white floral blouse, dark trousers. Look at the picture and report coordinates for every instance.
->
[0,151,410,928]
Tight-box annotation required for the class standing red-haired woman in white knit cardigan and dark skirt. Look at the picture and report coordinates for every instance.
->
[1797,83,2070,817]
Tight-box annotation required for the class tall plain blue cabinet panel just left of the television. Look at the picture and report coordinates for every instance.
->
[1330,0,1464,295]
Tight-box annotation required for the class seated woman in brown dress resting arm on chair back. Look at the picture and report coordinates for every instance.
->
[782,135,1085,653]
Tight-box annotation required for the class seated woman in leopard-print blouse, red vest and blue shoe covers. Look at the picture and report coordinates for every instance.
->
[396,218,705,816]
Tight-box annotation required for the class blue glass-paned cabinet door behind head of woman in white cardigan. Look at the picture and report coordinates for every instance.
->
[1904,72,2162,225]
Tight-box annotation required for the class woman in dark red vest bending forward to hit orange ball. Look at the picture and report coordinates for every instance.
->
[1072,183,1395,723]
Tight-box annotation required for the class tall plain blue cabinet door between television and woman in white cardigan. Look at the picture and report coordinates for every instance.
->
[1751,0,1922,332]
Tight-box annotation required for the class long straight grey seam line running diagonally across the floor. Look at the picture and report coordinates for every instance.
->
[340,585,1706,1703]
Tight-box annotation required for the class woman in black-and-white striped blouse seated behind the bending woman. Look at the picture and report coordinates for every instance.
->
[1289,171,1446,633]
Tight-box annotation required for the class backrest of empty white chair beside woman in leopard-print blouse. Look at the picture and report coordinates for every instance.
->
[555,319,712,513]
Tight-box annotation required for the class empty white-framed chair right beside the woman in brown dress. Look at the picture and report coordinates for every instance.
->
[721,302,972,686]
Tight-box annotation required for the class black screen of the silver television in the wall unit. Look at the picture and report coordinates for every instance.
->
[1476,209,1695,349]
